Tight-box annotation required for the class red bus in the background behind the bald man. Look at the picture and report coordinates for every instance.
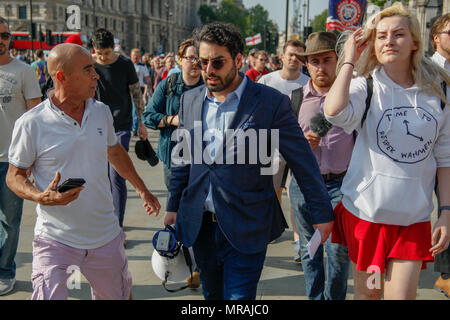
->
[11,31,88,50]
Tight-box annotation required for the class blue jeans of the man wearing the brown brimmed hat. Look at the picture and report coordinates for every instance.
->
[289,177,350,300]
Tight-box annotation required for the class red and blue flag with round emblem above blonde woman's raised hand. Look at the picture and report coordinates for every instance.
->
[327,0,367,32]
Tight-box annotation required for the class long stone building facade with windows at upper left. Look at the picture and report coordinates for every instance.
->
[0,0,202,53]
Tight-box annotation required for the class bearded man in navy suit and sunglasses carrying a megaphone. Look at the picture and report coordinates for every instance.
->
[164,22,334,300]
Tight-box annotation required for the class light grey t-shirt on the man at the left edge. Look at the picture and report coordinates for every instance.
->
[0,59,42,162]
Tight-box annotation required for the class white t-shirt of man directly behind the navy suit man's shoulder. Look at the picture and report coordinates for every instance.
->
[258,70,310,190]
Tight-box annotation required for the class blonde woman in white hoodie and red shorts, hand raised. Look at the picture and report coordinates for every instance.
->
[324,3,450,299]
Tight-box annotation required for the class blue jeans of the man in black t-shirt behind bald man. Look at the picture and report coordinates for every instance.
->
[108,131,131,227]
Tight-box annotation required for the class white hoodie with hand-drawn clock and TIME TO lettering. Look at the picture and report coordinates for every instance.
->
[326,67,450,226]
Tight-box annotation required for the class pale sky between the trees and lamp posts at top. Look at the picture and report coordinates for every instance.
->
[243,0,328,31]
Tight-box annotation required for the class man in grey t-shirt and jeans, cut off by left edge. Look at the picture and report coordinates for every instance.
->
[0,17,41,295]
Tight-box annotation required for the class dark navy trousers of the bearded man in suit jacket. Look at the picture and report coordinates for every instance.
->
[193,218,266,300]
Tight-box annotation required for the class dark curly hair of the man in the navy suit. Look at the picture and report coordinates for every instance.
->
[194,22,244,59]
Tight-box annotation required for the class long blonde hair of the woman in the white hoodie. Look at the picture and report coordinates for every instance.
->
[337,2,450,102]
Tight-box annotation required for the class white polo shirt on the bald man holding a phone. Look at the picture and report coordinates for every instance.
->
[9,99,120,249]
